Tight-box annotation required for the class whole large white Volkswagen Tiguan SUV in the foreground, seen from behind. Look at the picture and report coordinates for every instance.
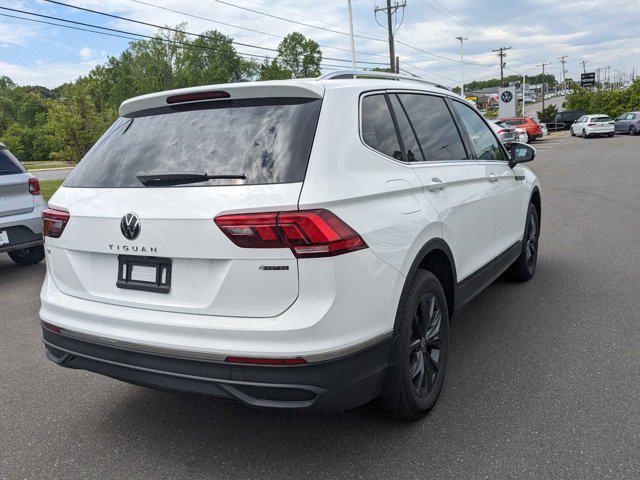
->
[40,71,541,419]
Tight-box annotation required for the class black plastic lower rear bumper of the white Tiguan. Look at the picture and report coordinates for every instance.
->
[43,328,391,412]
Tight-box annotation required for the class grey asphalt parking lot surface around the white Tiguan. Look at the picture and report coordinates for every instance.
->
[0,135,640,479]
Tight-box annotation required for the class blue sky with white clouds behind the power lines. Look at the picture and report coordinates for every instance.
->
[0,0,640,88]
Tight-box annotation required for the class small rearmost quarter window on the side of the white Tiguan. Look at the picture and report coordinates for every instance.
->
[362,94,402,160]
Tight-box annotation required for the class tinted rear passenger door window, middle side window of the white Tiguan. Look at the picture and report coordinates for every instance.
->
[400,93,467,161]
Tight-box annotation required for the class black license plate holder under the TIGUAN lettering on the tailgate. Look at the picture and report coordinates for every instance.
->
[116,255,171,293]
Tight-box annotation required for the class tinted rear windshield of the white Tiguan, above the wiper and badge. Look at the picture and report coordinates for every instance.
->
[64,98,322,188]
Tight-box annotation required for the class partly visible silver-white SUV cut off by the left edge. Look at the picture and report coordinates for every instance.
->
[0,143,47,265]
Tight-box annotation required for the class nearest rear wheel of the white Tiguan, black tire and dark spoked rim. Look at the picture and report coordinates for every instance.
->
[383,270,449,421]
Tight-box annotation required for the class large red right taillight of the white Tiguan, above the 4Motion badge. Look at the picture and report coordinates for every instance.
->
[214,209,367,258]
